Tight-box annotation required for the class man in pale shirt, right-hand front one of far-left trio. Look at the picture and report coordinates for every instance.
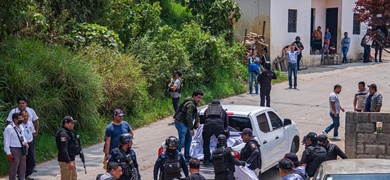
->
[20,110,35,178]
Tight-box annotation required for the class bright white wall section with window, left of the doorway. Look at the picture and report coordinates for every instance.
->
[269,0,311,66]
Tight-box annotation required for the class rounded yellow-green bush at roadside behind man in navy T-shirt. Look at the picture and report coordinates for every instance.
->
[78,45,149,116]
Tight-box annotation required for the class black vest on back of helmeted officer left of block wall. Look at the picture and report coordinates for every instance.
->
[306,145,328,177]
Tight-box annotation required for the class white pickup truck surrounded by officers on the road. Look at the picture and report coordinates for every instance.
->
[160,105,300,179]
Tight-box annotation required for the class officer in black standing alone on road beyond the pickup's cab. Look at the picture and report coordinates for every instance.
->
[257,61,277,107]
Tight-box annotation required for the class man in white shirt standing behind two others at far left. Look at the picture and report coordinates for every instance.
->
[7,96,39,138]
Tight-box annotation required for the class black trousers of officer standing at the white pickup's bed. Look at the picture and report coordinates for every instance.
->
[202,124,224,161]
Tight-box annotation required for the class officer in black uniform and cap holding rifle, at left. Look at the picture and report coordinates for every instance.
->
[56,116,81,180]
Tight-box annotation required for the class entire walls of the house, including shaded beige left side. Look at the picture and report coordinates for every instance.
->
[234,0,366,66]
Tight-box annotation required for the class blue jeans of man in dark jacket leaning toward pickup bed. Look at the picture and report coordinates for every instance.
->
[175,121,192,158]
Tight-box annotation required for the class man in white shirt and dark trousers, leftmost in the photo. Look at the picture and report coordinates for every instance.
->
[3,113,28,180]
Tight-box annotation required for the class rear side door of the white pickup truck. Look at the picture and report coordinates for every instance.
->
[256,112,277,170]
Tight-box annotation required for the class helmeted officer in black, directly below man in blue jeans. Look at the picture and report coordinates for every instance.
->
[153,136,188,180]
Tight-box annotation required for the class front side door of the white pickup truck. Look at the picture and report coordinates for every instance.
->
[267,111,290,159]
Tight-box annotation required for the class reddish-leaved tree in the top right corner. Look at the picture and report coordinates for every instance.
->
[353,0,390,26]
